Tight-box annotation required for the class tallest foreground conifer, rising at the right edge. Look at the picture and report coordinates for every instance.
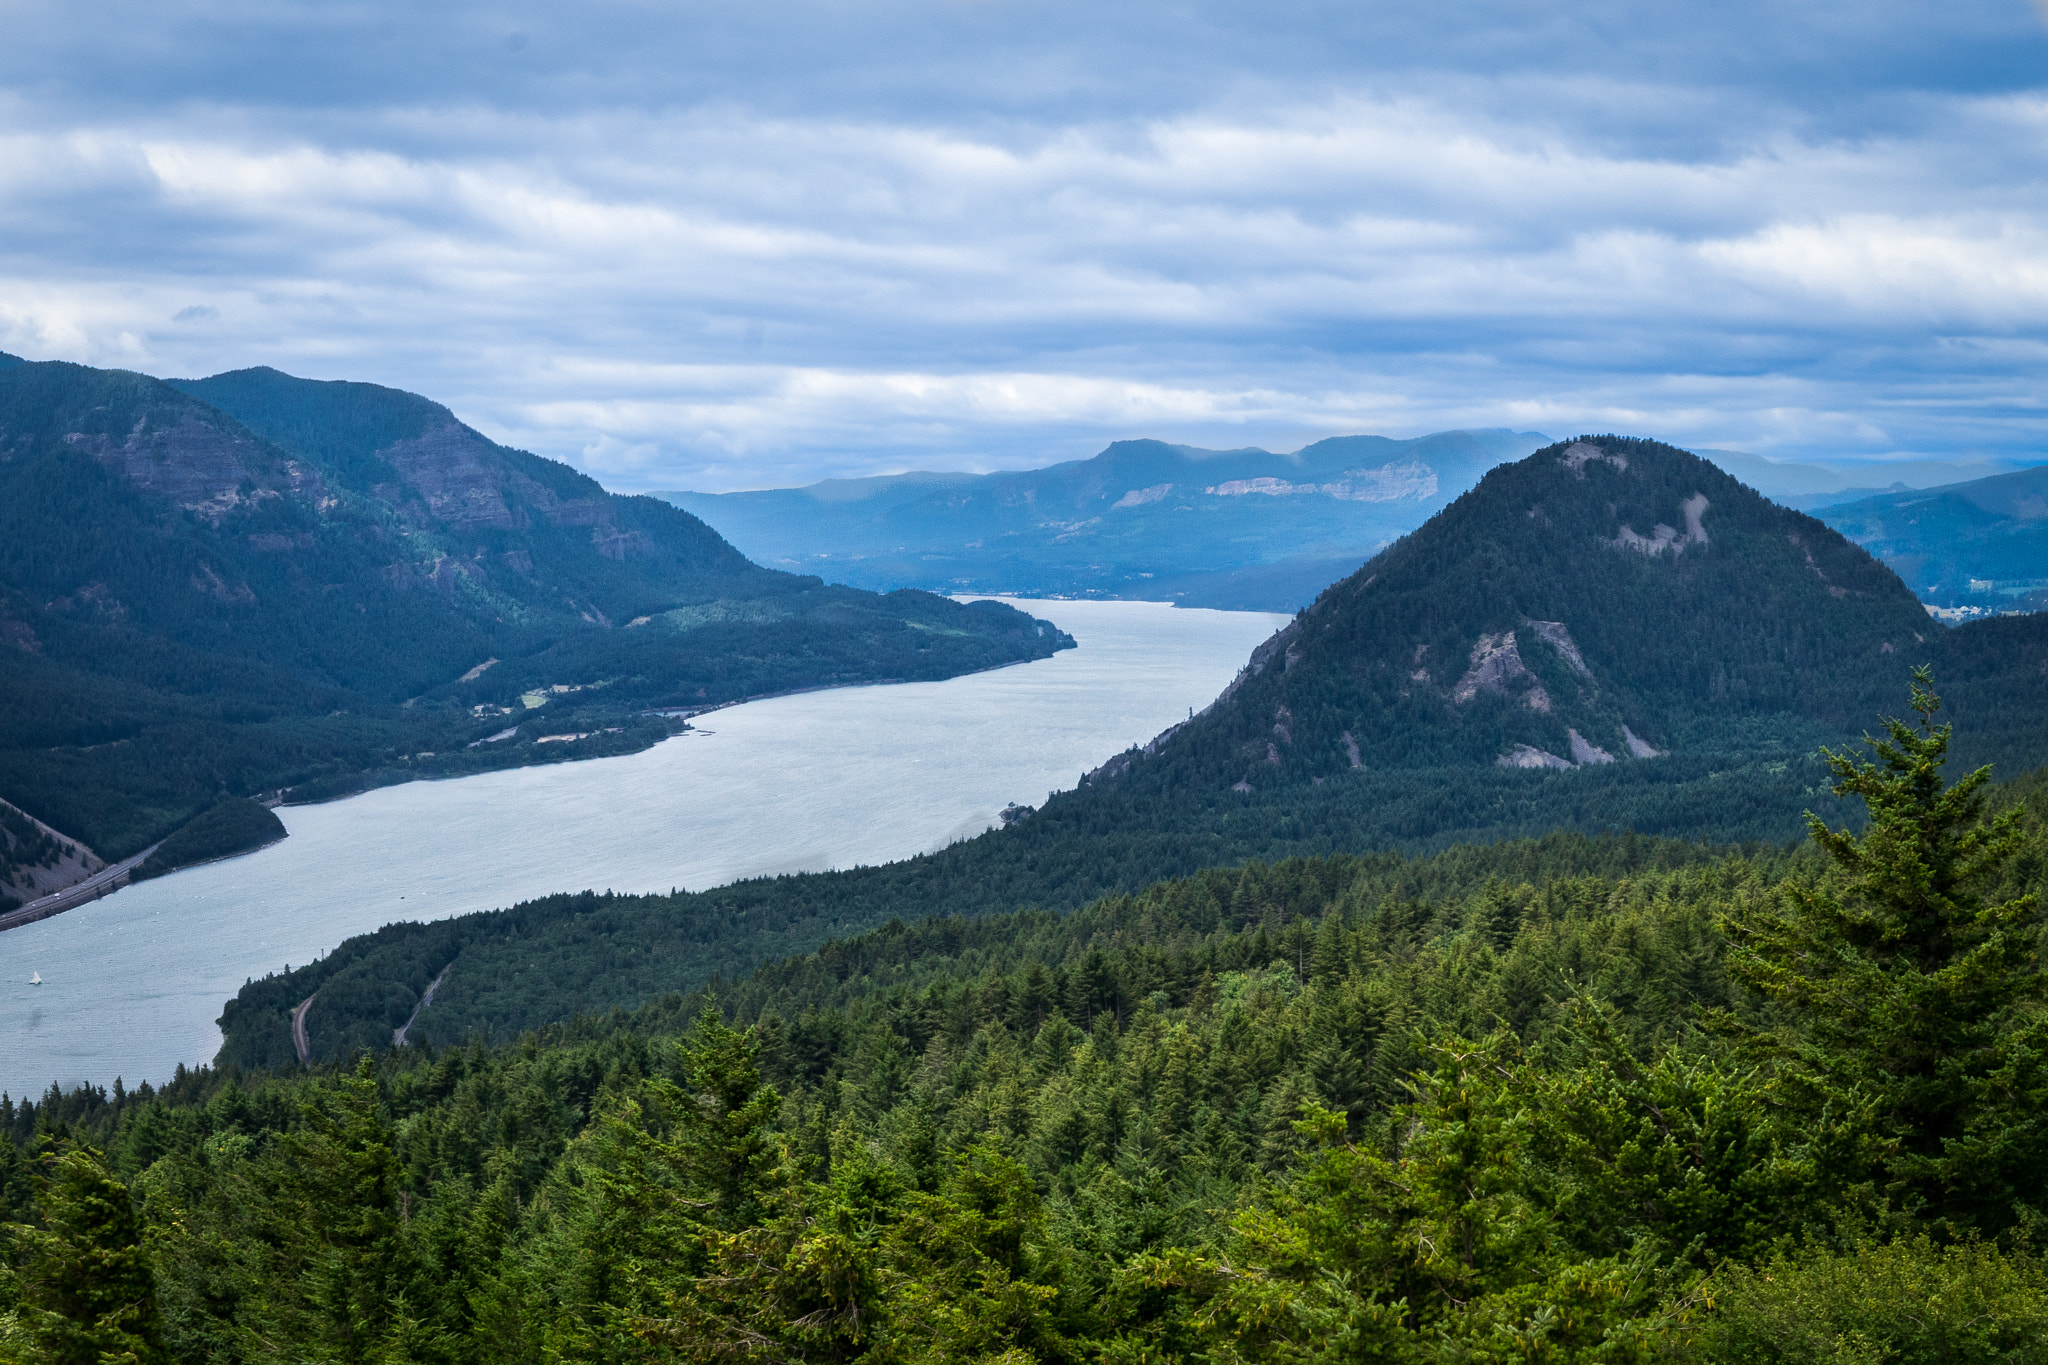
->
[1718,669,2048,1232]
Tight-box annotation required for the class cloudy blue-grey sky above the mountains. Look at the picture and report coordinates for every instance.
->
[0,0,2048,491]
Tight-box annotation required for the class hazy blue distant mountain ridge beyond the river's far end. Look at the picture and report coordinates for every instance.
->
[659,430,1544,610]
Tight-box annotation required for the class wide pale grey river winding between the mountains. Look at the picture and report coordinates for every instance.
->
[0,602,1286,1097]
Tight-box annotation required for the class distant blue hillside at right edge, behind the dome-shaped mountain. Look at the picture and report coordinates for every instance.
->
[1817,465,2048,610]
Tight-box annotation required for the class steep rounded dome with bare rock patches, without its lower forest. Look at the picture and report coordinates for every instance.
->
[1153,438,1942,788]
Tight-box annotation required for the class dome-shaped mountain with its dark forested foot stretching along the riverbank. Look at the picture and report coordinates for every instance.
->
[207,436,2048,1064]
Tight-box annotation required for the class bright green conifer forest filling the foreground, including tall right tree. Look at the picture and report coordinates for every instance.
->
[0,686,2048,1365]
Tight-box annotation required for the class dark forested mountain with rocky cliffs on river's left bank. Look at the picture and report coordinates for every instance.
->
[0,351,1071,896]
